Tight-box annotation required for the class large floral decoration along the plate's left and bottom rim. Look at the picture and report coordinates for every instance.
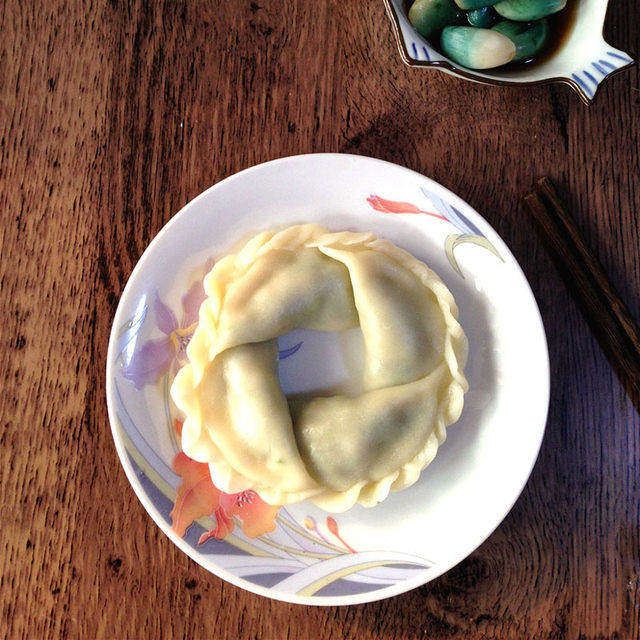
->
[116,278,432,597]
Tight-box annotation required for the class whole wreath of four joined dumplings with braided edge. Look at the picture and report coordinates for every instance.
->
[171,224,467,511]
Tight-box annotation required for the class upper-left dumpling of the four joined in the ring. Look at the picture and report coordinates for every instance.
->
[189,225,358,380]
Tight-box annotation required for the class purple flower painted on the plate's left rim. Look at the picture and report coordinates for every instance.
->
[122,280,206,390]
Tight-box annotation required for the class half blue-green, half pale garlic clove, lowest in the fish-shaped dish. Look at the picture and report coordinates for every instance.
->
[440,27,516,69]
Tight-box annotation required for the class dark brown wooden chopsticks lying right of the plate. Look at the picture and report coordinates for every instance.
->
[524,178,640,412]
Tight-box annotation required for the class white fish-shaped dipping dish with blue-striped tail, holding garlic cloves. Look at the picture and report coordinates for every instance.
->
[384,0,634,104]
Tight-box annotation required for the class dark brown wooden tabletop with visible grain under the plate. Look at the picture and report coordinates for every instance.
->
[0,0,640,640]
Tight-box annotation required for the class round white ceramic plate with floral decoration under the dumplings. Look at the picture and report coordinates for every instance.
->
[107,154,549,605]
